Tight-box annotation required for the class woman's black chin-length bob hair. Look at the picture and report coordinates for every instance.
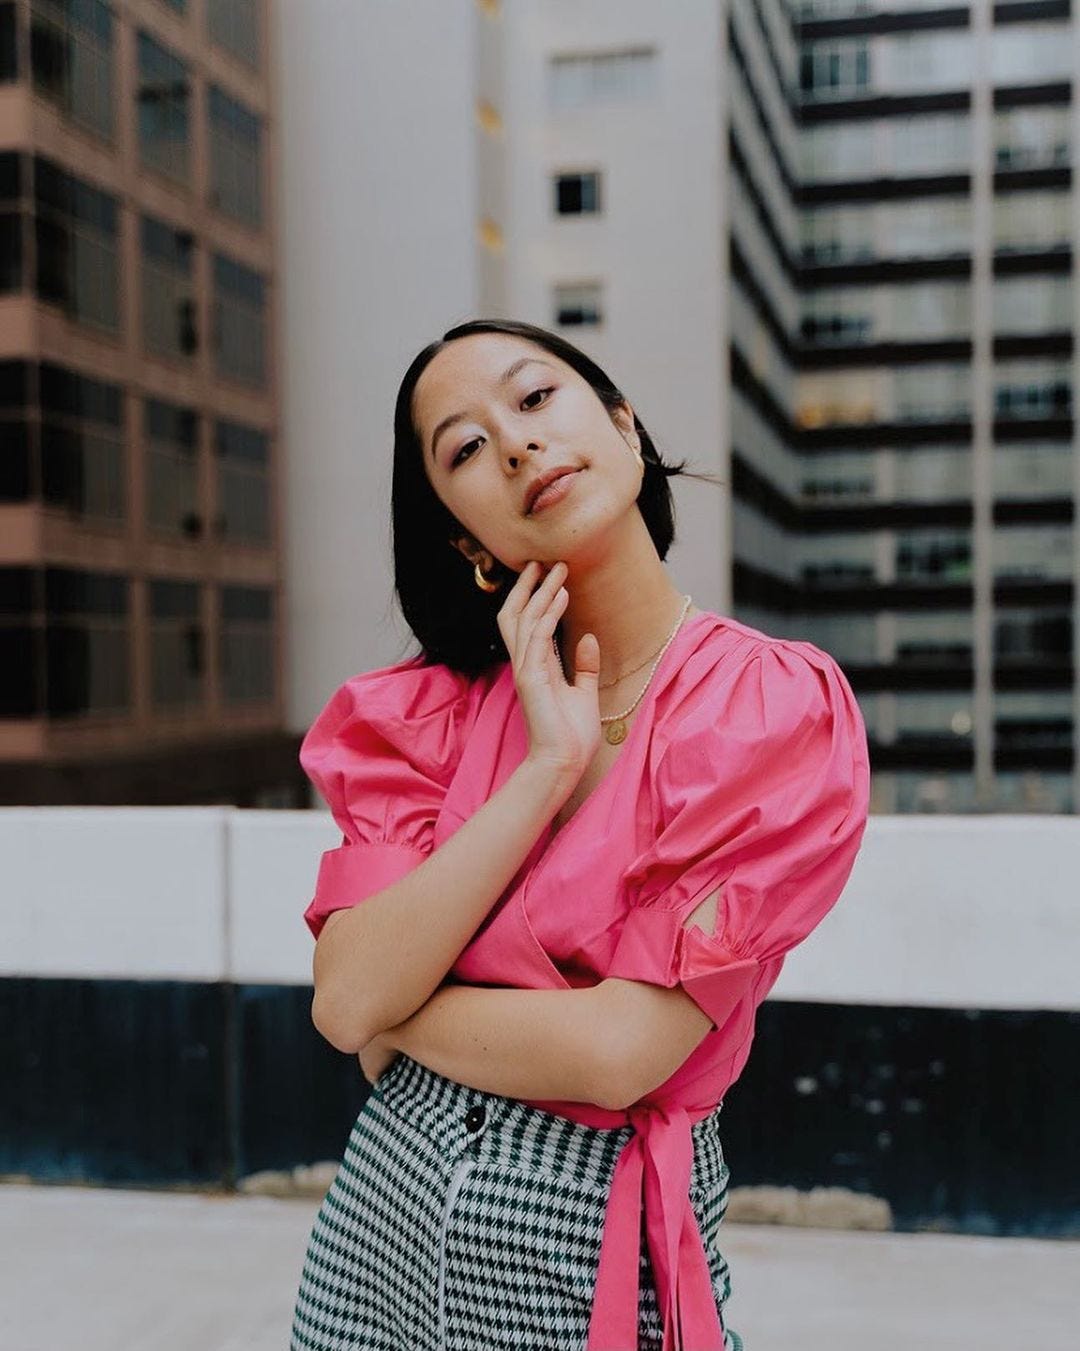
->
[391,319,720,677]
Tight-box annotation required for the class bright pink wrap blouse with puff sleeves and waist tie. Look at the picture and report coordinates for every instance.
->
[300,611,870,1351]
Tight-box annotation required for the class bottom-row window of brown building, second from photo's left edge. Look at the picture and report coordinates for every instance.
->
[45,567,131,717]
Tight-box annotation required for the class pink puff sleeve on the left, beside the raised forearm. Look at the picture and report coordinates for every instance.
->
[299,655,469,939]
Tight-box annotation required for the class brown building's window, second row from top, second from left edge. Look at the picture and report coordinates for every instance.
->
[34,158,120,331]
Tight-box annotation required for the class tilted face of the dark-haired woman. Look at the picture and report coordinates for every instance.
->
[412,334,642,571]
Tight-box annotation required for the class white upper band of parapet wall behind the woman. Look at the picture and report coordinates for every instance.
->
[0,807,1080,1009]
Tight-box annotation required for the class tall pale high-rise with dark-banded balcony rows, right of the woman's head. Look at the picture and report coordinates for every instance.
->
[476,0,1080,812]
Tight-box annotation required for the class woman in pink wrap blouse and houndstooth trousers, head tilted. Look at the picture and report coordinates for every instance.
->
[292,322,869,1351]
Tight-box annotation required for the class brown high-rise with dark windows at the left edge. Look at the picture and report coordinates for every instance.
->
[0,0,297,805]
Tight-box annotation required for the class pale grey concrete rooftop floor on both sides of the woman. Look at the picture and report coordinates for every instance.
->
[0,1185,1080,1351]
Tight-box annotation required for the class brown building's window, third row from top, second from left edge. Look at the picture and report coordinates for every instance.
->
[39,363,126,523]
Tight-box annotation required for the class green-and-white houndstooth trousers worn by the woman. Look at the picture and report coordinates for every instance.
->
[289,1055,742,1351]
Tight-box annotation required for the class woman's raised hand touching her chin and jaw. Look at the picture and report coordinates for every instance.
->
[497,559,600,782]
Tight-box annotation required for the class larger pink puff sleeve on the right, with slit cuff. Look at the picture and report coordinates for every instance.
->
[607,639,870,1028]
